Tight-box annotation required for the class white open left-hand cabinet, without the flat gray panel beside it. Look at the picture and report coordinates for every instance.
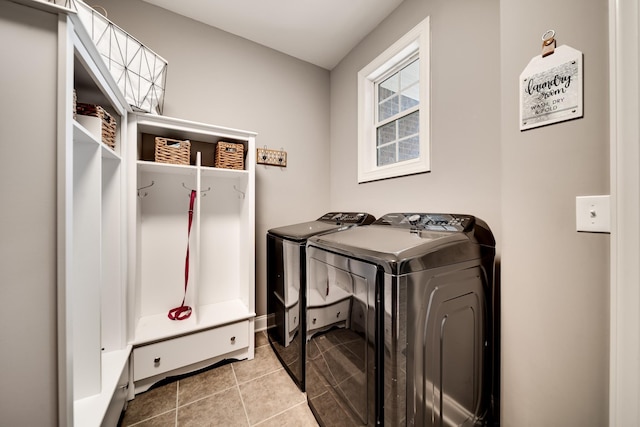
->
[65,8,131,427]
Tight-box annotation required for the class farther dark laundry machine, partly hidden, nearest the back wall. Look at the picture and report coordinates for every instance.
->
[267,212,375,391]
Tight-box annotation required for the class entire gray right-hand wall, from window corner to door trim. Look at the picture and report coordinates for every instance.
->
[330,0,609,427]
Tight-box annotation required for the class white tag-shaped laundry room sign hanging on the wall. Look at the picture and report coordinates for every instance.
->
[520,45,582,130]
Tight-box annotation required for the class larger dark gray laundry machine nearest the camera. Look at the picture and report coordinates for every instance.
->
[306,213,500,427]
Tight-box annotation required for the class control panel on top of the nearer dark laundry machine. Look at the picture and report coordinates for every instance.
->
[374,213,475,232]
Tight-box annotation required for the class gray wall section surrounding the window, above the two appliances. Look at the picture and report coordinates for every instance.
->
[330,0,501,235]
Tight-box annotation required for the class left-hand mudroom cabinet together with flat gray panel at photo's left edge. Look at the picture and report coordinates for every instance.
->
[0,0,131,427]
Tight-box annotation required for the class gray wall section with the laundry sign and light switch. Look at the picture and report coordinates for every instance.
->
[500,0,609,427]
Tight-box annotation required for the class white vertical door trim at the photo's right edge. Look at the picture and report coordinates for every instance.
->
[609,0,640,427]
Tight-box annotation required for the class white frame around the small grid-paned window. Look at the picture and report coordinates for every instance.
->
[358,17,431,183]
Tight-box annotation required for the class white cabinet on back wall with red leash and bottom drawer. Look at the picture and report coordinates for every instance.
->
[128,113,255,393]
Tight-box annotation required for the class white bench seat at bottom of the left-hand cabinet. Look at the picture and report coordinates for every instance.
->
[73,346,131,427]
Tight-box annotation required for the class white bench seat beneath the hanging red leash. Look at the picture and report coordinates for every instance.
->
[132,299,255,346]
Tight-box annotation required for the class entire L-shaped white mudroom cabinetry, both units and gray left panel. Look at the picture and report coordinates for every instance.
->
[0,0,255,427]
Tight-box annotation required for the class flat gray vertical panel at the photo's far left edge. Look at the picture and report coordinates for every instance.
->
[0,1,58,426]
